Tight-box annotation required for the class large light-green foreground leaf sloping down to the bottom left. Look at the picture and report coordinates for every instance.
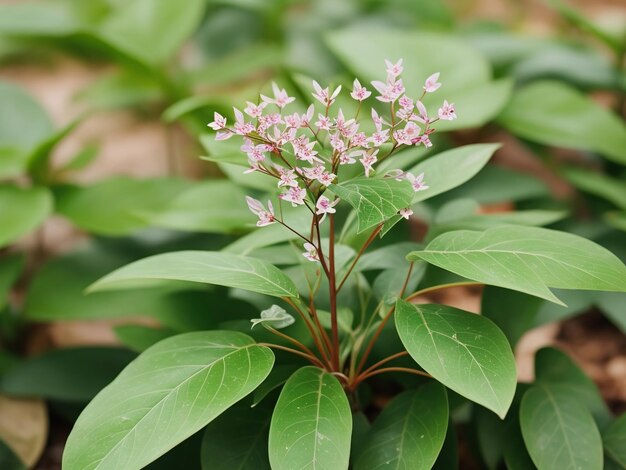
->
[63,331,274,470]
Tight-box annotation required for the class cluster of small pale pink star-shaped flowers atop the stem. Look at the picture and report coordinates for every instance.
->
[208,59,456,261]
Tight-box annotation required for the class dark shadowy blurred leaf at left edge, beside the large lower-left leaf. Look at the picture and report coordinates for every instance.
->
[0,347,135,402]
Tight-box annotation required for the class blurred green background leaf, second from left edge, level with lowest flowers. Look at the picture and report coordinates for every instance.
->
[55,177,190,236]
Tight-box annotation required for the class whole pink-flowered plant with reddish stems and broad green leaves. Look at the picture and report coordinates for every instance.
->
[59,60,626,469]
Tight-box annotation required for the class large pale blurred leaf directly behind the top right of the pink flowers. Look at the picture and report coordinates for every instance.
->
[327,26,511,130]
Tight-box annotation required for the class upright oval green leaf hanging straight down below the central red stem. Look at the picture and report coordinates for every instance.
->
[269,367,352,470]
